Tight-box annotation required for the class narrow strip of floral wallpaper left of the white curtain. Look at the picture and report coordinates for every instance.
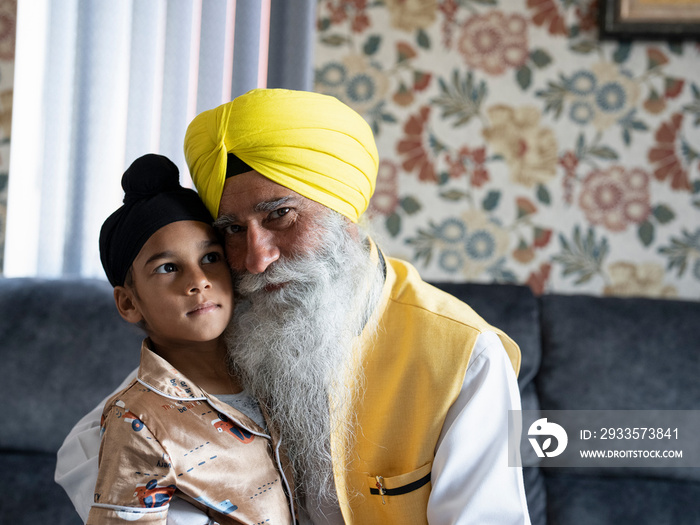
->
[0,0,17,274]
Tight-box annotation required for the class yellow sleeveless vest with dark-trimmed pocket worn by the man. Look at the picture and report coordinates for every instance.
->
[331,252,520,525]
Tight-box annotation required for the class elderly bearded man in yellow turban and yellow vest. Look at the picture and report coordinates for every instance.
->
[57,90,529,524]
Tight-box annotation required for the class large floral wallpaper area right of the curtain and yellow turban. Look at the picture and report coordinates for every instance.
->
[315,0,700,300]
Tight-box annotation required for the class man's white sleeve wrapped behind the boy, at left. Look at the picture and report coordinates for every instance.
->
[54,369,212,525]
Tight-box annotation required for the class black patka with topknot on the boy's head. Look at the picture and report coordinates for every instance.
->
[100,153,212,286]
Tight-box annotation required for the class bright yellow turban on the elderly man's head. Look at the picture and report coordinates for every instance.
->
[180,89,379,222]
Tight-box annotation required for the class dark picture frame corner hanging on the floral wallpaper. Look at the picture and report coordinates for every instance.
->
[598,0,700,40]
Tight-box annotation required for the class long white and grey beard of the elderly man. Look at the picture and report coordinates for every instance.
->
[227,212,384,509]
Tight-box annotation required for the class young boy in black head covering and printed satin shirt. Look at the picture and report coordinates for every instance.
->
[87,154,293,525]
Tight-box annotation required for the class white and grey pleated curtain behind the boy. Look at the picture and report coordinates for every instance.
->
[4,0,315,278]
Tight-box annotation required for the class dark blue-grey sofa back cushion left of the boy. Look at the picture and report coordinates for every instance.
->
[0,279,144,452]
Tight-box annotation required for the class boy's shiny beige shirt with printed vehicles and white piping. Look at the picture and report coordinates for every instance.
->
[87,339,293,525]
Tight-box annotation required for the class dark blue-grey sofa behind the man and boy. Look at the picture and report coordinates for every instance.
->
[0,278,700,525]
